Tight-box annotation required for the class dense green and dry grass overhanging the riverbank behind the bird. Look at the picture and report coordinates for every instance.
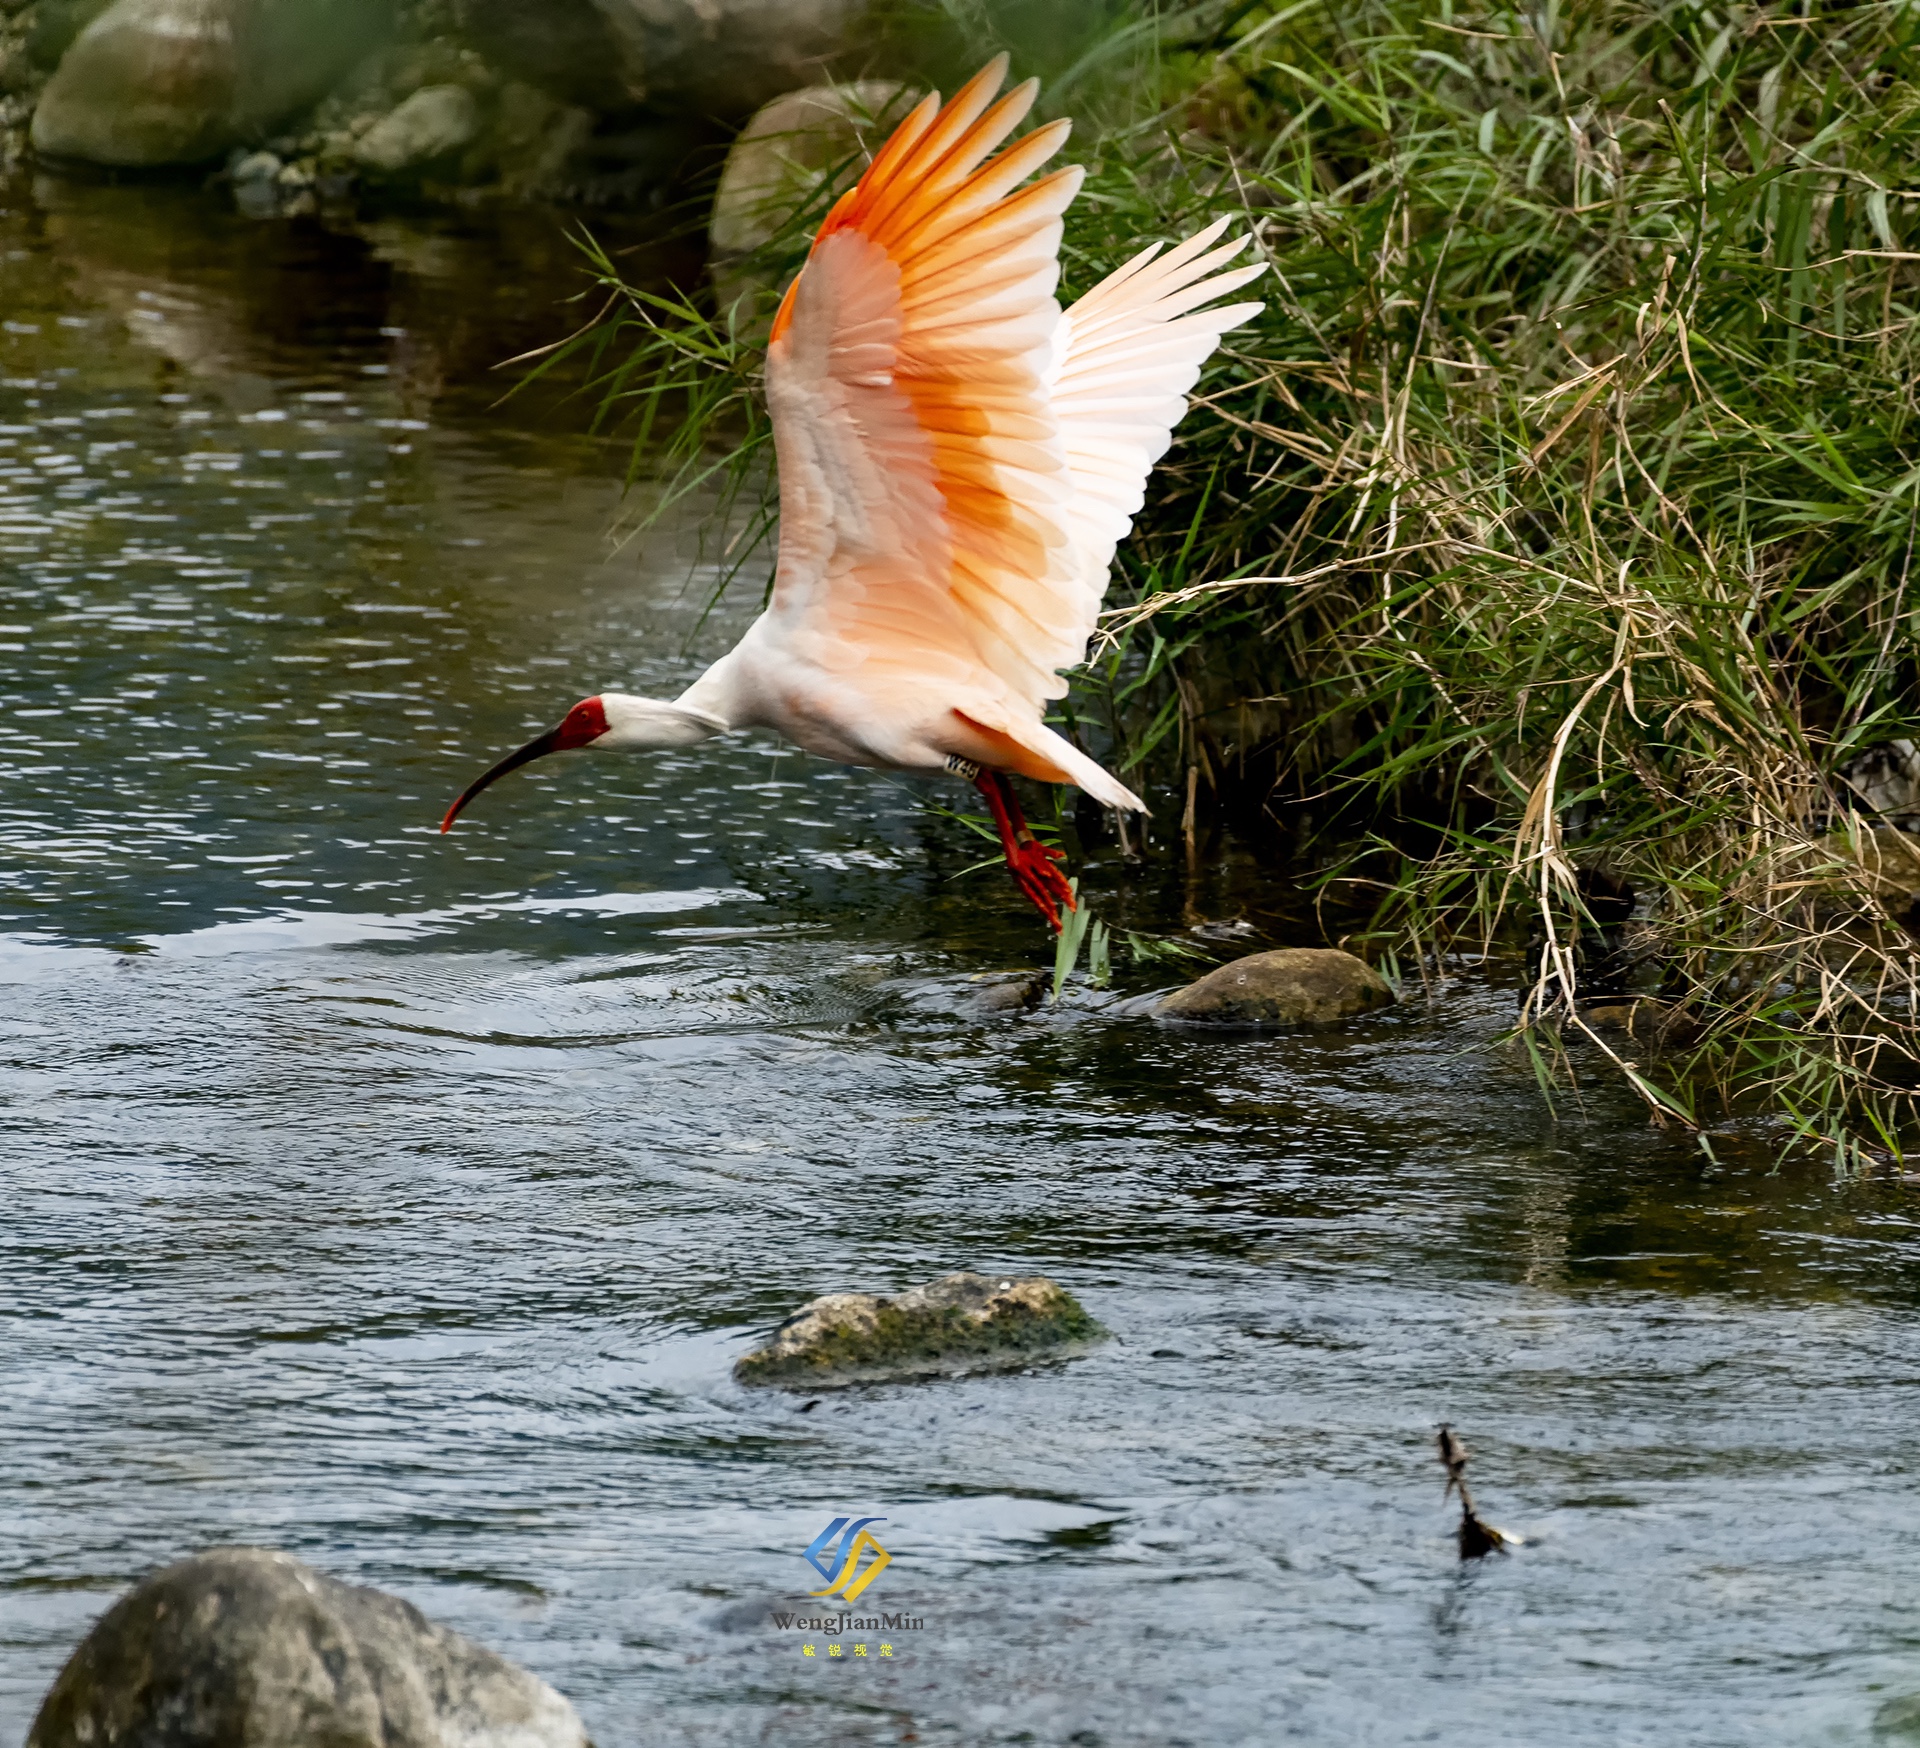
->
[568,0,1920,1168]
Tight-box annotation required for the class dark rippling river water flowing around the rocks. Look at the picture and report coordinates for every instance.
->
[0,174,1920,1748]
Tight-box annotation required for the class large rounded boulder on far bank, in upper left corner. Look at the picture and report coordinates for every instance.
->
[33,0,388,165]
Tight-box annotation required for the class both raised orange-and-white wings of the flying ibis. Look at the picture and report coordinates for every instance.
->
[766,58,1260,722]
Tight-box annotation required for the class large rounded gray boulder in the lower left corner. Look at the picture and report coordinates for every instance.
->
[27,1548,588,1748]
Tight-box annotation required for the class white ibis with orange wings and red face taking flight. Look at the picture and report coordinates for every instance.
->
[442,56,1261,930]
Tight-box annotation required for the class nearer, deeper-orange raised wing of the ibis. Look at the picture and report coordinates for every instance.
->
[766,60,1081,705]
